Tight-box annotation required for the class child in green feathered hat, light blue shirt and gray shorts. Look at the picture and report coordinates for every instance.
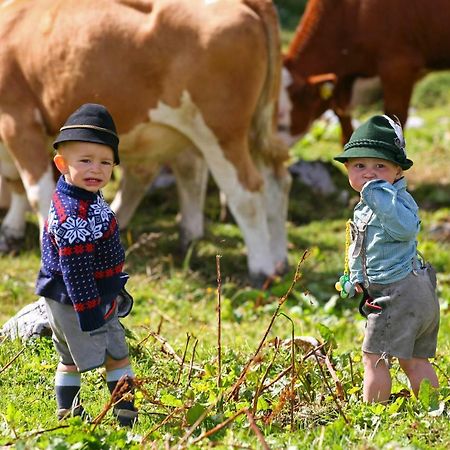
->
[334,115,439,402]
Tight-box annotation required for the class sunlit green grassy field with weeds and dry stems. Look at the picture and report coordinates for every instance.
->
[0,5,450,450]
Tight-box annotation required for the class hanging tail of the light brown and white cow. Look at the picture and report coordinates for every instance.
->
[243,0,289,165]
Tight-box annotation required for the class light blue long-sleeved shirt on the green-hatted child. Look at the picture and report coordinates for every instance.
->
[349,178,420,284]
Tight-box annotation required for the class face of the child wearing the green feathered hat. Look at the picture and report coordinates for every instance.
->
[345,158,403,192]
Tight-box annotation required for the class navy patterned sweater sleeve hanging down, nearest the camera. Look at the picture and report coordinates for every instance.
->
[56,216,105,331]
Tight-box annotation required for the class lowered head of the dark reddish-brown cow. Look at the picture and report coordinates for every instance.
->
[278,65,337,146]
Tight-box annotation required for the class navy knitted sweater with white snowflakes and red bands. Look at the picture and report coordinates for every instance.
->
[36,176,128,331]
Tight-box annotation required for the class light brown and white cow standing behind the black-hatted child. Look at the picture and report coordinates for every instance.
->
[0,0,290,277]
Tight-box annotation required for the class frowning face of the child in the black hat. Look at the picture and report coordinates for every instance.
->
[54,141,114,192]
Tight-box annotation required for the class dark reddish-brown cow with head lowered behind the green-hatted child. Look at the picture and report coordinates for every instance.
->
[280,0,450,143]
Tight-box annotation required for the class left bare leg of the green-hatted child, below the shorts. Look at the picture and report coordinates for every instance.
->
[363,352,392,403]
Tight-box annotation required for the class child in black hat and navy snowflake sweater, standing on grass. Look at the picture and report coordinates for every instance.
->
[36,103,137,425]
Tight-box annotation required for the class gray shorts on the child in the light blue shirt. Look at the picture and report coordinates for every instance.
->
[362,264,439,359]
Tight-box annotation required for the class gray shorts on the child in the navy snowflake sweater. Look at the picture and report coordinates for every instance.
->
[45,298,128,372]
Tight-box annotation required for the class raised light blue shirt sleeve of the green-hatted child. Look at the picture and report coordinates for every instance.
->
[361,180,420,241]
